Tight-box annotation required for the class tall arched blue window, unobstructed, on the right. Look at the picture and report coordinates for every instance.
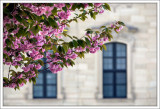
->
[103,42,127,98]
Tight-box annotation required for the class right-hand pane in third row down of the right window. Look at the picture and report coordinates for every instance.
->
[116,72,126,84]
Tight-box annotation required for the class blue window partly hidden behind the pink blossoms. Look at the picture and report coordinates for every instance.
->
[33,50,57,98]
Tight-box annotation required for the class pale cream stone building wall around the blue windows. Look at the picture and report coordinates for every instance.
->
[3,3,158,106]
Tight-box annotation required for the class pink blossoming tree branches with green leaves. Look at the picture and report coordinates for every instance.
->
[3,3,125,89]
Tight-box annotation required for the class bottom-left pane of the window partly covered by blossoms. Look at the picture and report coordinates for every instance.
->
[33,86,43,97]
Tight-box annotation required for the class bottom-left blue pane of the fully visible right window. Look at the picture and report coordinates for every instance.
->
[103,85,113,97]
